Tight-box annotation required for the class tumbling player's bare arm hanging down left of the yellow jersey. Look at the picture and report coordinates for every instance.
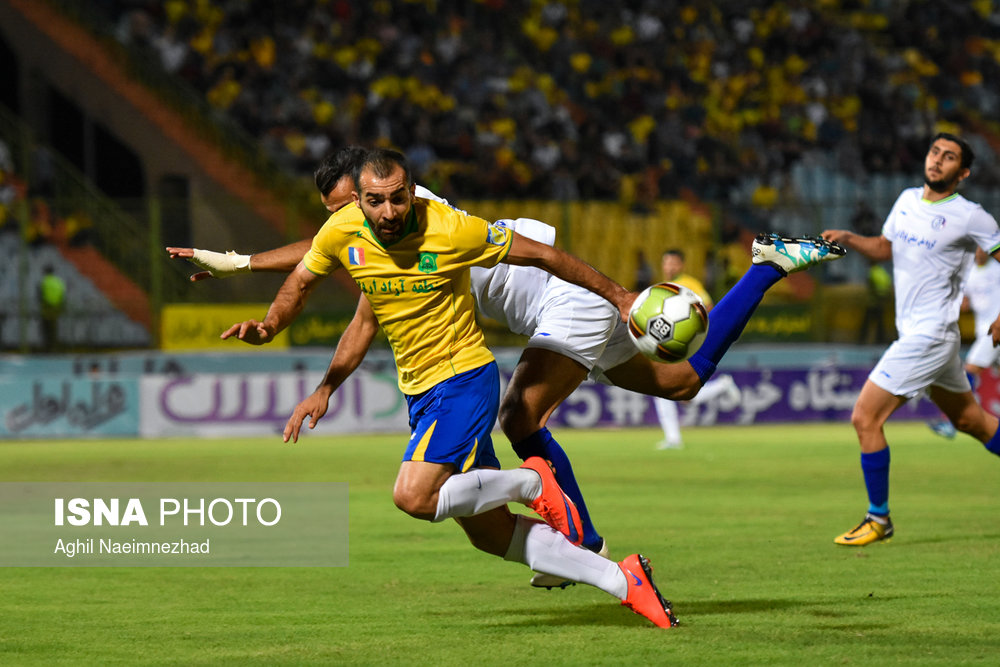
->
[282,294,378,442]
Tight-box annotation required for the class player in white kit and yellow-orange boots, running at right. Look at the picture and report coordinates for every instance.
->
[823,133,1000,546]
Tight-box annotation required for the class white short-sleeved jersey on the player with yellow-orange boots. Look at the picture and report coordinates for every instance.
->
[882,188,1000,338]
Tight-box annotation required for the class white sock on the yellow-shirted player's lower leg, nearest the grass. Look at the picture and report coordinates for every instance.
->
[503,514,628,600]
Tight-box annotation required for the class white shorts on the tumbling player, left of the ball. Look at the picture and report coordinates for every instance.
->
[527,277,620,371]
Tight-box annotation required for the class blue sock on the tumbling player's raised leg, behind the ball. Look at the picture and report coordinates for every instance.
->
[684,264,783,384]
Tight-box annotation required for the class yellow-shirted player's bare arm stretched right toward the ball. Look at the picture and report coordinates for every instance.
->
[503,232,638,321]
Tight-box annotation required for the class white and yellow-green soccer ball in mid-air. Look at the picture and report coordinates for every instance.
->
[628,283,708,363]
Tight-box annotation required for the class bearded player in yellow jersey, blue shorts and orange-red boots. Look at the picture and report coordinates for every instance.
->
[222,149,677,627]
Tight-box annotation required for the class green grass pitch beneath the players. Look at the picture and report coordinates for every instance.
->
[0,423,1000,665]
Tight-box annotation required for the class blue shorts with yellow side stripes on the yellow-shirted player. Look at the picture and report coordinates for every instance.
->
[403,361,500,472]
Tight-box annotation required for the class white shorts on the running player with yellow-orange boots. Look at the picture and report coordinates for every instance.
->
[868,332,972,398]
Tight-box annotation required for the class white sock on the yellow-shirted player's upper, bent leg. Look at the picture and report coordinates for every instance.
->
[432,468,540,520]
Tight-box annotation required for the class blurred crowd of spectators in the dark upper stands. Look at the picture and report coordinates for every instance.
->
[100,0,1000,205]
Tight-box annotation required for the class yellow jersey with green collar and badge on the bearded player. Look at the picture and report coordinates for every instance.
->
[302,198,514,395]
